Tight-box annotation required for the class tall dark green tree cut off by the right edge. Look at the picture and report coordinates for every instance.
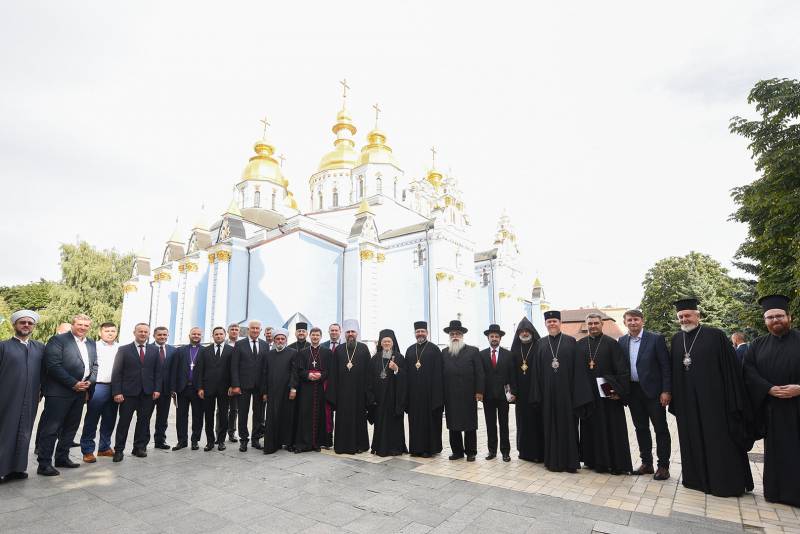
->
[730,79,800,319]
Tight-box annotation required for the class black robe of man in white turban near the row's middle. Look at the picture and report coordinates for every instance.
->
[261,347,297,454]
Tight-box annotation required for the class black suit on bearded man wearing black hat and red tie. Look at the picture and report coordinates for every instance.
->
[480,347,516,458]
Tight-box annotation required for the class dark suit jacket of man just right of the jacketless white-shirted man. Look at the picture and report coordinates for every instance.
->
[111,342,163,397]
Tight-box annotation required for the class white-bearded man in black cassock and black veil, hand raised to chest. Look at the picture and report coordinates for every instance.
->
[370,330,408,456]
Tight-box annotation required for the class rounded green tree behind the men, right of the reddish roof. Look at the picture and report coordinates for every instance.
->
[641,252,763,339]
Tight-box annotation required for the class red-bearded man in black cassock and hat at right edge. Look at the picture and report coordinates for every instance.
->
[744,295,800,507]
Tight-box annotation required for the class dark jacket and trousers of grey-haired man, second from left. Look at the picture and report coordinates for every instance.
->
[38,332,97,466]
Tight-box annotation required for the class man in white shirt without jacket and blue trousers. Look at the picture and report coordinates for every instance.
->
[81,323,119,464]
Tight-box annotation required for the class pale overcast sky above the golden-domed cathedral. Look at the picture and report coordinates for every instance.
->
[0,0,800,307]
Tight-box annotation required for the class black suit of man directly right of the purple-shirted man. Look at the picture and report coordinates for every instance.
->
[195,343,233,445]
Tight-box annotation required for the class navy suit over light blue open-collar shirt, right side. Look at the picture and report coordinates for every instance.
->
[618,330,672,468]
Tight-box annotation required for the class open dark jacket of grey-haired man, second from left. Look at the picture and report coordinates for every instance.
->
[44,332,97,397]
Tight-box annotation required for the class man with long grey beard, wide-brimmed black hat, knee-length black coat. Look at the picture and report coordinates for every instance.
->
[442,320,484,462]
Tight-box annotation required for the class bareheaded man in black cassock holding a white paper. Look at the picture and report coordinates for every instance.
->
[577,313,633,475]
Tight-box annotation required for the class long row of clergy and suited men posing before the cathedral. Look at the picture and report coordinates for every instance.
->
[0,295,800,506]
